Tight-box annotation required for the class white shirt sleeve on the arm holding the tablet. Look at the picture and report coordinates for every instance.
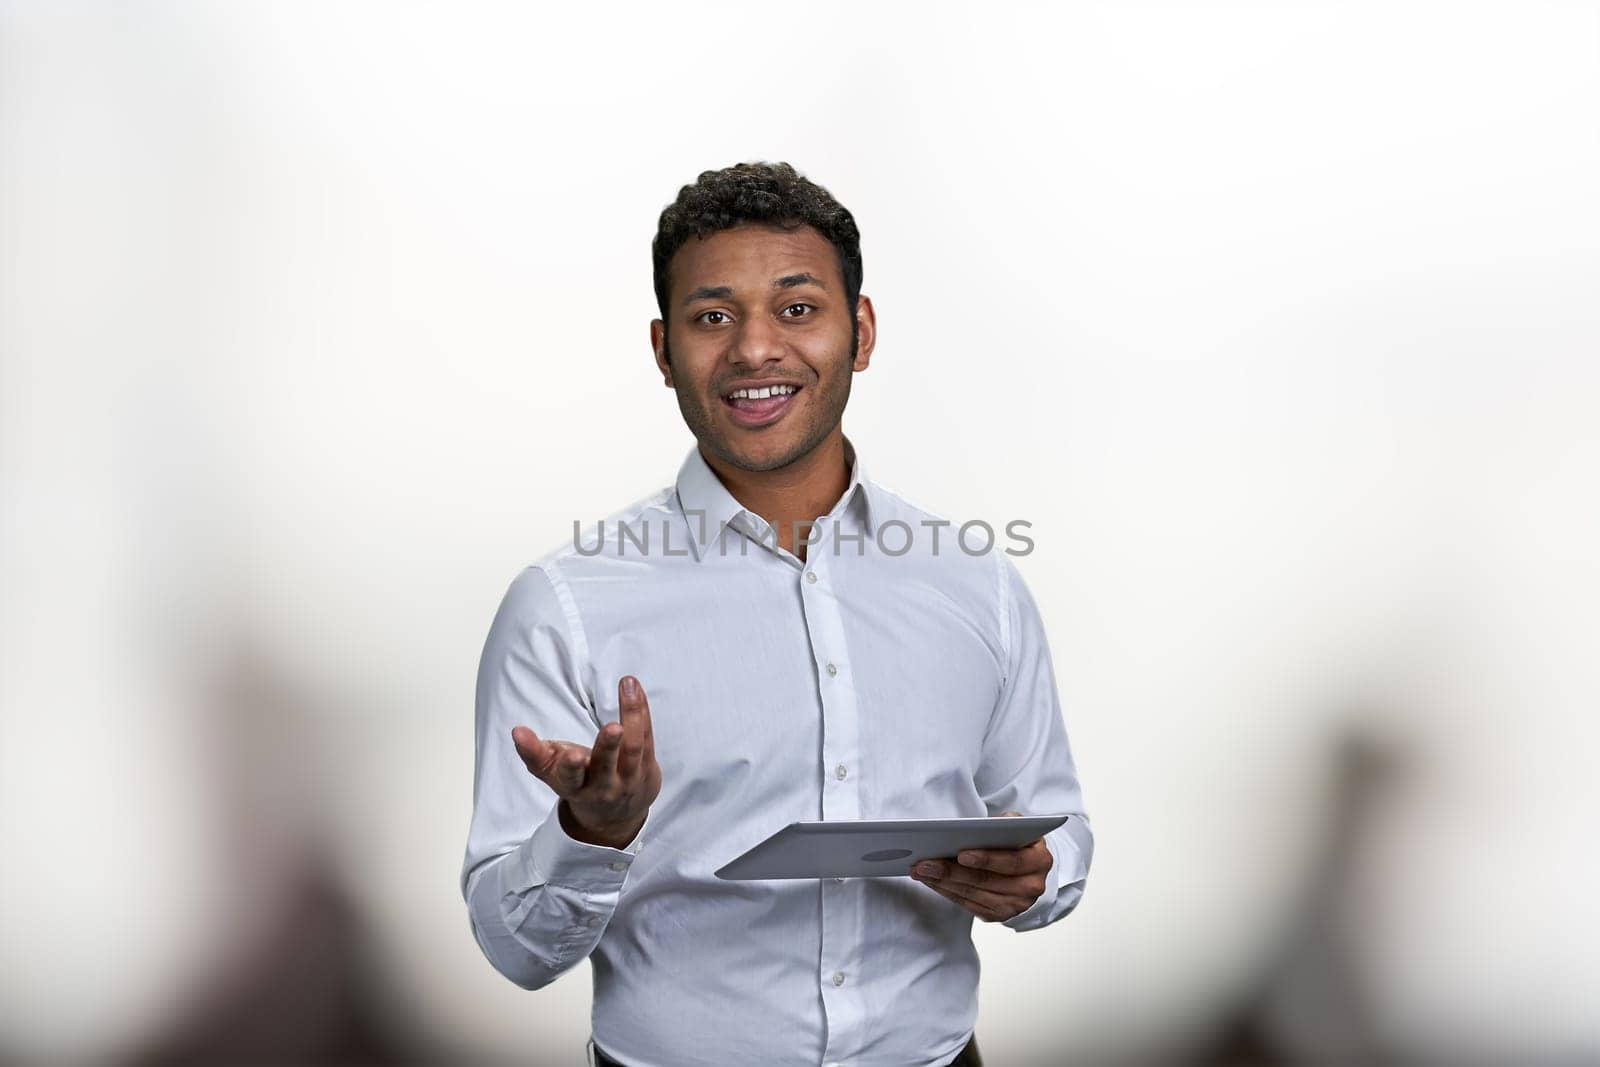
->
[976,553,1094,931]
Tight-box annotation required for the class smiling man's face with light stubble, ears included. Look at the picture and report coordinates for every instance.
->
[650,226,877,470]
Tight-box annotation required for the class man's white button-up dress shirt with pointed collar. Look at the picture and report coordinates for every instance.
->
[461,440,1093,1067]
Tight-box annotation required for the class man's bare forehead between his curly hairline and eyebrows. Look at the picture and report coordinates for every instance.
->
[667,222,842,294]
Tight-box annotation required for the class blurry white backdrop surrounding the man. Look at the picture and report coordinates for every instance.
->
[0,3,1600,1064]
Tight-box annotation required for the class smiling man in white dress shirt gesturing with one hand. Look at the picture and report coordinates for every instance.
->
[462,163,1093,1067]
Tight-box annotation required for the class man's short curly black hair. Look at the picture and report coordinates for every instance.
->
[650,163,861,318]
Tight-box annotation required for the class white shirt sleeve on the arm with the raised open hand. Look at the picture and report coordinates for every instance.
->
[461,565,650,989]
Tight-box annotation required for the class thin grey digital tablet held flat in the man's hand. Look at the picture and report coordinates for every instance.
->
[717,814,1072,881]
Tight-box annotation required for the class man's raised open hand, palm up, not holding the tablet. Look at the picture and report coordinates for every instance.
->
[510,675,661,848]
